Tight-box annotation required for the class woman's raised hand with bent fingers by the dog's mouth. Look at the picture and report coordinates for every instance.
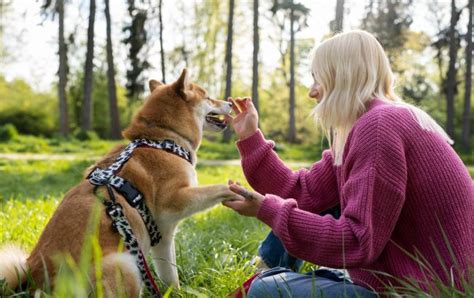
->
[226,97,258,139]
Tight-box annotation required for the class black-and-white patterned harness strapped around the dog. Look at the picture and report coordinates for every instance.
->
[87,139,192,297]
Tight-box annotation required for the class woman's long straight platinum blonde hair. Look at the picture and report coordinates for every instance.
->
[312,30,453,165]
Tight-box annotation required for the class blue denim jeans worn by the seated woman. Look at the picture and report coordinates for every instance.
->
[247,208,378,298]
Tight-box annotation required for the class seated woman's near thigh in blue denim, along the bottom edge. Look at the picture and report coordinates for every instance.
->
[247,268,377,298]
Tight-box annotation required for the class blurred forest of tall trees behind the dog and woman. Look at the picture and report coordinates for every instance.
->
[0,0,473,152]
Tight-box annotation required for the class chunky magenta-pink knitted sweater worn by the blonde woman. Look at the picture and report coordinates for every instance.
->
[237,99,474,291]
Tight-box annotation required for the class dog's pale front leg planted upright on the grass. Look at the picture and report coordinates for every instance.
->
[151,227,179,289]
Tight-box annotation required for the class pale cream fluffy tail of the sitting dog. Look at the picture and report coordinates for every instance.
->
[0,245,28,294]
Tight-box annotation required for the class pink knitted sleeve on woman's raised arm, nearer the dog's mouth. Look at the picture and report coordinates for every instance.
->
[237,130,339,213]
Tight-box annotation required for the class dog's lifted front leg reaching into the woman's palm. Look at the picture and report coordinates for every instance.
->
[173,184,235,218]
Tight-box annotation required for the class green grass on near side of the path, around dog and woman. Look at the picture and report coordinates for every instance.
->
[0,145,474,297]
